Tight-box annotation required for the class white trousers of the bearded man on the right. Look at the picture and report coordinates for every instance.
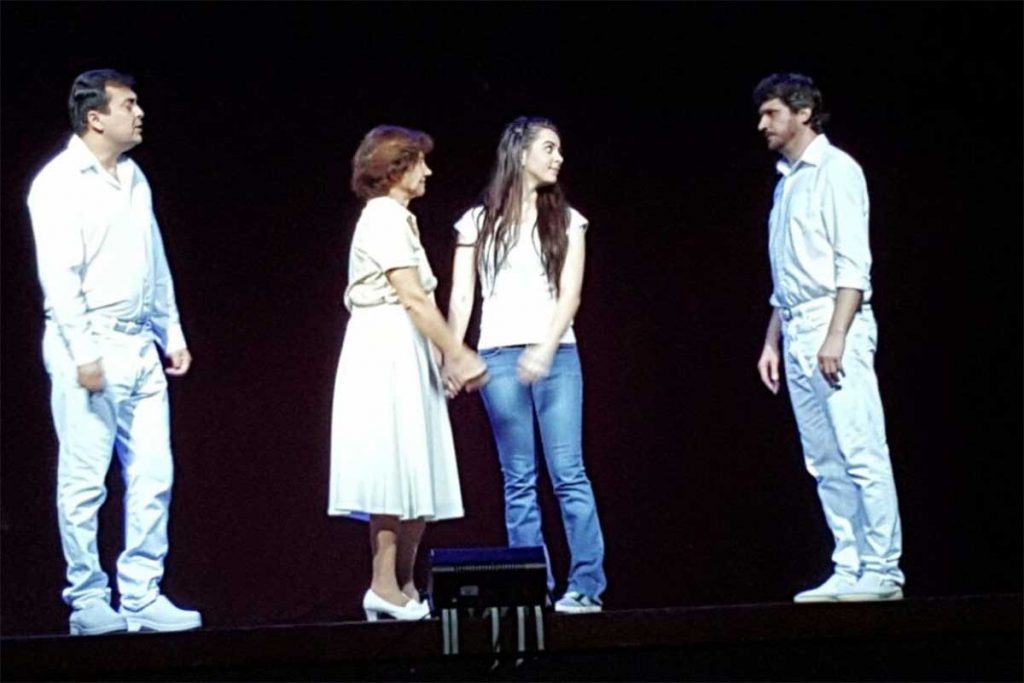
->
[781,299,903,585]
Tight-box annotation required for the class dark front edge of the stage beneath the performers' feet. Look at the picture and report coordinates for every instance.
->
[0,594,1024,681]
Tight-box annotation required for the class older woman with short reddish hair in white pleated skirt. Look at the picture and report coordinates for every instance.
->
[328,126,485,621]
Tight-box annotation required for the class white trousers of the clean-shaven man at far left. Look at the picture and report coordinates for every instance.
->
[43,323,173,609]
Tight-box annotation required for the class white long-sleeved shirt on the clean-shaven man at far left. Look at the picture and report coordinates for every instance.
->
[29,135,185,366]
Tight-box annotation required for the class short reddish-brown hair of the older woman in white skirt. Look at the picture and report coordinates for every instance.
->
[352,126,434,201]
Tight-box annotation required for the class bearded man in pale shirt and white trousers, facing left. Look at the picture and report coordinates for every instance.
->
[754,74,904,602]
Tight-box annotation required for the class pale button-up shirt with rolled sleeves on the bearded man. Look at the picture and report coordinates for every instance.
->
[768,135,871,308]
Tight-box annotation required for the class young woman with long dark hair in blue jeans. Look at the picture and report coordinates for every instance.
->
[445,117,606,612]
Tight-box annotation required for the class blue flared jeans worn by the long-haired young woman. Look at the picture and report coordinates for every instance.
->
[480,344,607,598]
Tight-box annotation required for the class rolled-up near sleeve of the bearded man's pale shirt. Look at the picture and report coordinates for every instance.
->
[822,164,871,292]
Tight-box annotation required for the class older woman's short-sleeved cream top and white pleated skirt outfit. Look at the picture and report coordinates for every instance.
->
[328,197,463,520]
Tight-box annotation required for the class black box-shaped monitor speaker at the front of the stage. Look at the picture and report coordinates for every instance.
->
[430,546,548,613]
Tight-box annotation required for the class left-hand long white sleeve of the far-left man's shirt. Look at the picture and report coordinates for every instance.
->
[28,176,101,366]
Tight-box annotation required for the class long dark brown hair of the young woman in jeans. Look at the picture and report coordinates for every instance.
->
[476,117,569,293]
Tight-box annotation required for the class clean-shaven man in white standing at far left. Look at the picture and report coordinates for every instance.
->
[28,70,202,635]
